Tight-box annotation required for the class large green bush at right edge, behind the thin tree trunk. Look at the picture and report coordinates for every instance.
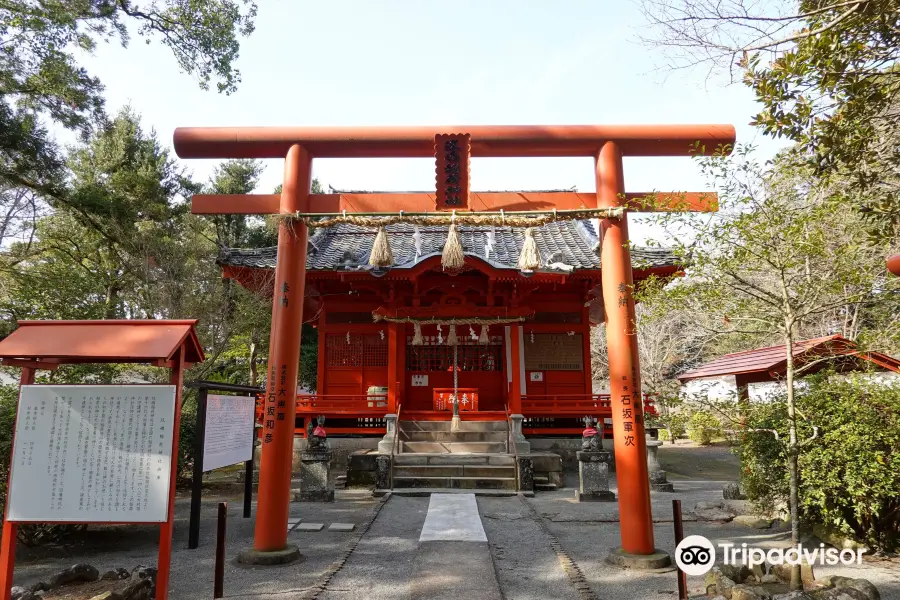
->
[738,376,900,552]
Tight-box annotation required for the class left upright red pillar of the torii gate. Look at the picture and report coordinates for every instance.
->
[253,144,312,552]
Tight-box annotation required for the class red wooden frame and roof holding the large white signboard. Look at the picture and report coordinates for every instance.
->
[0,320,204,600]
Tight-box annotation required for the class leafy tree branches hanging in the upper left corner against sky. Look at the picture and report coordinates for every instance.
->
[0,0,256,203]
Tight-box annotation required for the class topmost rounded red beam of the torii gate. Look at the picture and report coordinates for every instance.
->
[173,124,735,158]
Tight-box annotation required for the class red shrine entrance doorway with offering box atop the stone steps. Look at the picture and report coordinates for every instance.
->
[404,325,507,412]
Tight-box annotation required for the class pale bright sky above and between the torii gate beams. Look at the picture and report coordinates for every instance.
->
[74,0,779,237]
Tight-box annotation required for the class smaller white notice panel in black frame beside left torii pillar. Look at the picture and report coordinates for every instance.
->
[203,394,256,472]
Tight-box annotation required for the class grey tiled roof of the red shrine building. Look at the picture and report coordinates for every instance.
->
[218,221,678,272]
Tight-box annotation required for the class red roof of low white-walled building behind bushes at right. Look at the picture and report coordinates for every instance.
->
[678,335,900,400]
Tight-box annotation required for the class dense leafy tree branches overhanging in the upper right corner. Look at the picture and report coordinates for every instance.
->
[741,0,900,239]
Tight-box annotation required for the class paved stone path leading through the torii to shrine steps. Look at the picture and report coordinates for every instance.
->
[318,494,580,600]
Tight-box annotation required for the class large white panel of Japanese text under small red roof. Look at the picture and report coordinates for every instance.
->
[7,385,175,523]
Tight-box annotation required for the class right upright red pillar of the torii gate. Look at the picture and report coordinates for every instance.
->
[596,142,654,554]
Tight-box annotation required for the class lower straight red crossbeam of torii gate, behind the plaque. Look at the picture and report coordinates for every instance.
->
[191,192,719,215]
